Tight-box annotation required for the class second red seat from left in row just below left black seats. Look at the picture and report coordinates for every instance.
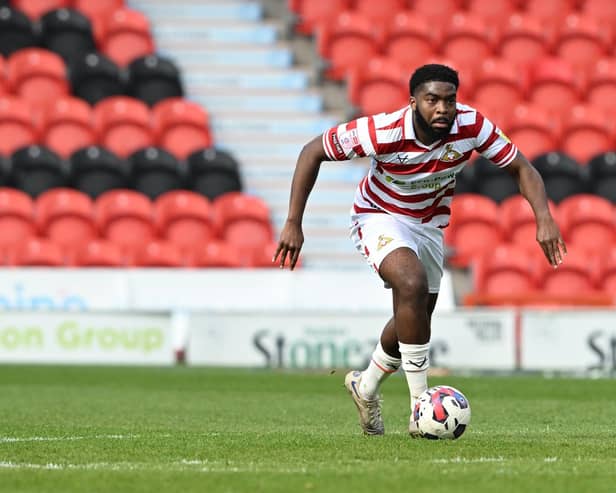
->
[36,188,97,251]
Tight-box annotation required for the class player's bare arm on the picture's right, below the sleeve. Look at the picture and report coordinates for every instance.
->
[506,151,567,268]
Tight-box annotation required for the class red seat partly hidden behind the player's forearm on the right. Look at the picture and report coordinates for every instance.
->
[499,194,561,254]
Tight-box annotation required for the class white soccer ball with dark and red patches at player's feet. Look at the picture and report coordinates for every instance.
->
[413,385,471,440]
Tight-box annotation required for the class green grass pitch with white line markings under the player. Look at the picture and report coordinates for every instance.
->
[0,366,616,493]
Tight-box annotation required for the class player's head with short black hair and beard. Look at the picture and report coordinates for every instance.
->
[409,63,460,139]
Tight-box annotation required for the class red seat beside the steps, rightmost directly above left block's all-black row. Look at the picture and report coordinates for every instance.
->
[152,98,212,159]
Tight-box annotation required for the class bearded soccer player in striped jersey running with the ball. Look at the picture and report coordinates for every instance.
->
[273,64,566,436]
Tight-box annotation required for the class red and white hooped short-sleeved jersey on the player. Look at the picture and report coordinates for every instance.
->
[323,103,517,228]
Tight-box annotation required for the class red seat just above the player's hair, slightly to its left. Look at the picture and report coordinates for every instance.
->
[377,11,440,66]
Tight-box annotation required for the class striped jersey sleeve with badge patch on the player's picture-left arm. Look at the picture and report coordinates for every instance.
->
[323,116,377,161]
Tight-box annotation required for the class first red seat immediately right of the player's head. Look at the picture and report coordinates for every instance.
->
[473,58,526,108]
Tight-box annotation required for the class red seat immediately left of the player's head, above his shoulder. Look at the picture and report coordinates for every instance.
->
[347,57,409,115]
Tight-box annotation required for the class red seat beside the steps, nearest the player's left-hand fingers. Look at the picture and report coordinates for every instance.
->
[213,192,273,252]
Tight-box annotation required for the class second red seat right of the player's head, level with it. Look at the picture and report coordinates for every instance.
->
[529,58,580,117]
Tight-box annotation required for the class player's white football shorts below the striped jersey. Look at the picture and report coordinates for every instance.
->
[351,212,444,293]
